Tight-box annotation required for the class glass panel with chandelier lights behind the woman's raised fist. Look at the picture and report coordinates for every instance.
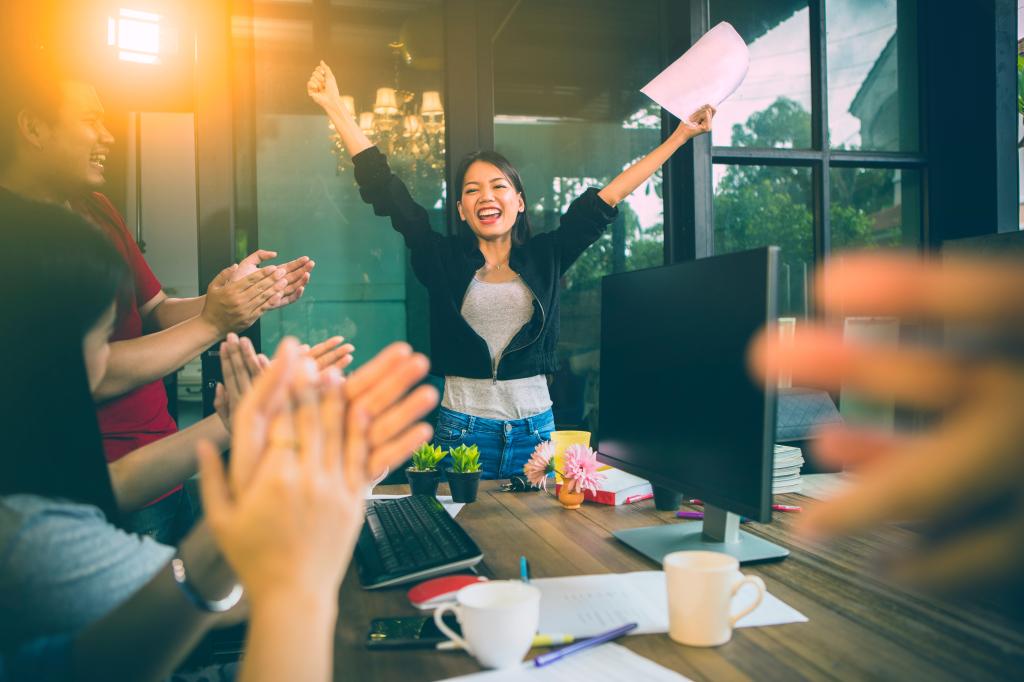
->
[246,0,444,363]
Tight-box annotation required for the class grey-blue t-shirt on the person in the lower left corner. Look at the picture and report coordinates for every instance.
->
[0,495,175,644]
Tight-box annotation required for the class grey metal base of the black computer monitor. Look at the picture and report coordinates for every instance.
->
[611,505,790,564]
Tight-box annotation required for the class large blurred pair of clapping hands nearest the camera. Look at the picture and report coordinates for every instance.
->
[200,338,437,609]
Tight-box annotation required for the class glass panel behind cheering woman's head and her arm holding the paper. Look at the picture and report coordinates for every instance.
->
[495,0,664,428]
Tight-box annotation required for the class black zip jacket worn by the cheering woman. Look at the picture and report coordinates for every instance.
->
[352,146,618,380]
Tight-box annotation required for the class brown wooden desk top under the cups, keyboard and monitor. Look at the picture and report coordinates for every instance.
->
[335,481,1024,682]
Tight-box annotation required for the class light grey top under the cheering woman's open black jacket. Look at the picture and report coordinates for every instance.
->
[441,278,551,420]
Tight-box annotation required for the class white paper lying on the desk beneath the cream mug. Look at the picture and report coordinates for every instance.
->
[530,570,807,637]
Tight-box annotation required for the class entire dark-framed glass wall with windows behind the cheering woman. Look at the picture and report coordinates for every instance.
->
[224,0,927,428]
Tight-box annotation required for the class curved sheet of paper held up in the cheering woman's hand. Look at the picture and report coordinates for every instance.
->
[640,22,751,120]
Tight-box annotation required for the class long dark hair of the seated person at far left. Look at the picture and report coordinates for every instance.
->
[0,189,127,521]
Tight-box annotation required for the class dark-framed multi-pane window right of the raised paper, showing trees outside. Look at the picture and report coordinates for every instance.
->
[710,0,926,316]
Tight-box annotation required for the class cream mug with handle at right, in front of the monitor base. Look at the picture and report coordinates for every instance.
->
[665,552,765,646]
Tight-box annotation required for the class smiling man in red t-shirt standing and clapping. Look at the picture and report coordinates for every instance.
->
[0,74,313,542]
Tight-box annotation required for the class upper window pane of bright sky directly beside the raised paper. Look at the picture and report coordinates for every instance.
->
[711,0,811,148]
